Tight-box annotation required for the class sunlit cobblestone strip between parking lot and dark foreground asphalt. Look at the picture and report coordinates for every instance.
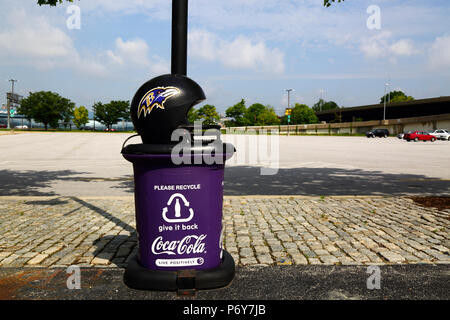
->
[0,196,450,267]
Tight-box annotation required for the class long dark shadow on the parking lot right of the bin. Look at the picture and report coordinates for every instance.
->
[224,166,450,196]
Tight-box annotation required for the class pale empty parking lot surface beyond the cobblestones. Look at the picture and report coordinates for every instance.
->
[0,132,450,196]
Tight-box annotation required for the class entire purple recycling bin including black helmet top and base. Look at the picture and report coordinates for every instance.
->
[121,74,235,290]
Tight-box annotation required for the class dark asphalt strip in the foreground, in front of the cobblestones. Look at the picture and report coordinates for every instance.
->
[0,264,450,300]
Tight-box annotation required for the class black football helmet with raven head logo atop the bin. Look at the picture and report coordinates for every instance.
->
[130,74,206,144]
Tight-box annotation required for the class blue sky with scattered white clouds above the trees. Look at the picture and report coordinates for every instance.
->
[0,0,450,114]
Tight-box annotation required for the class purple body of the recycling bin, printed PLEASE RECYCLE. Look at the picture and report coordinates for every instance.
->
[123,151,232,271]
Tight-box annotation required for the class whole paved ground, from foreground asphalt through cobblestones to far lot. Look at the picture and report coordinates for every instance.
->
[0,133,450,299]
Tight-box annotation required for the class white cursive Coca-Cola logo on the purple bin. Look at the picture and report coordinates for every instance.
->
[152,234,206,255]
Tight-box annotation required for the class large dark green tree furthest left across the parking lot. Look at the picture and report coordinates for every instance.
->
[18,91,75,130]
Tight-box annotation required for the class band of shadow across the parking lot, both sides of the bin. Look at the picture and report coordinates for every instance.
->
[0,166,450,196]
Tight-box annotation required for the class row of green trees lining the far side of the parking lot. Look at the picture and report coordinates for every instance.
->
[17,87,414,130]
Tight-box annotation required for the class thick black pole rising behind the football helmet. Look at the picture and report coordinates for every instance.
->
[172,0,188,76]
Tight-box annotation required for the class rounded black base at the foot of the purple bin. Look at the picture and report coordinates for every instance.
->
[123,250,235,291]
